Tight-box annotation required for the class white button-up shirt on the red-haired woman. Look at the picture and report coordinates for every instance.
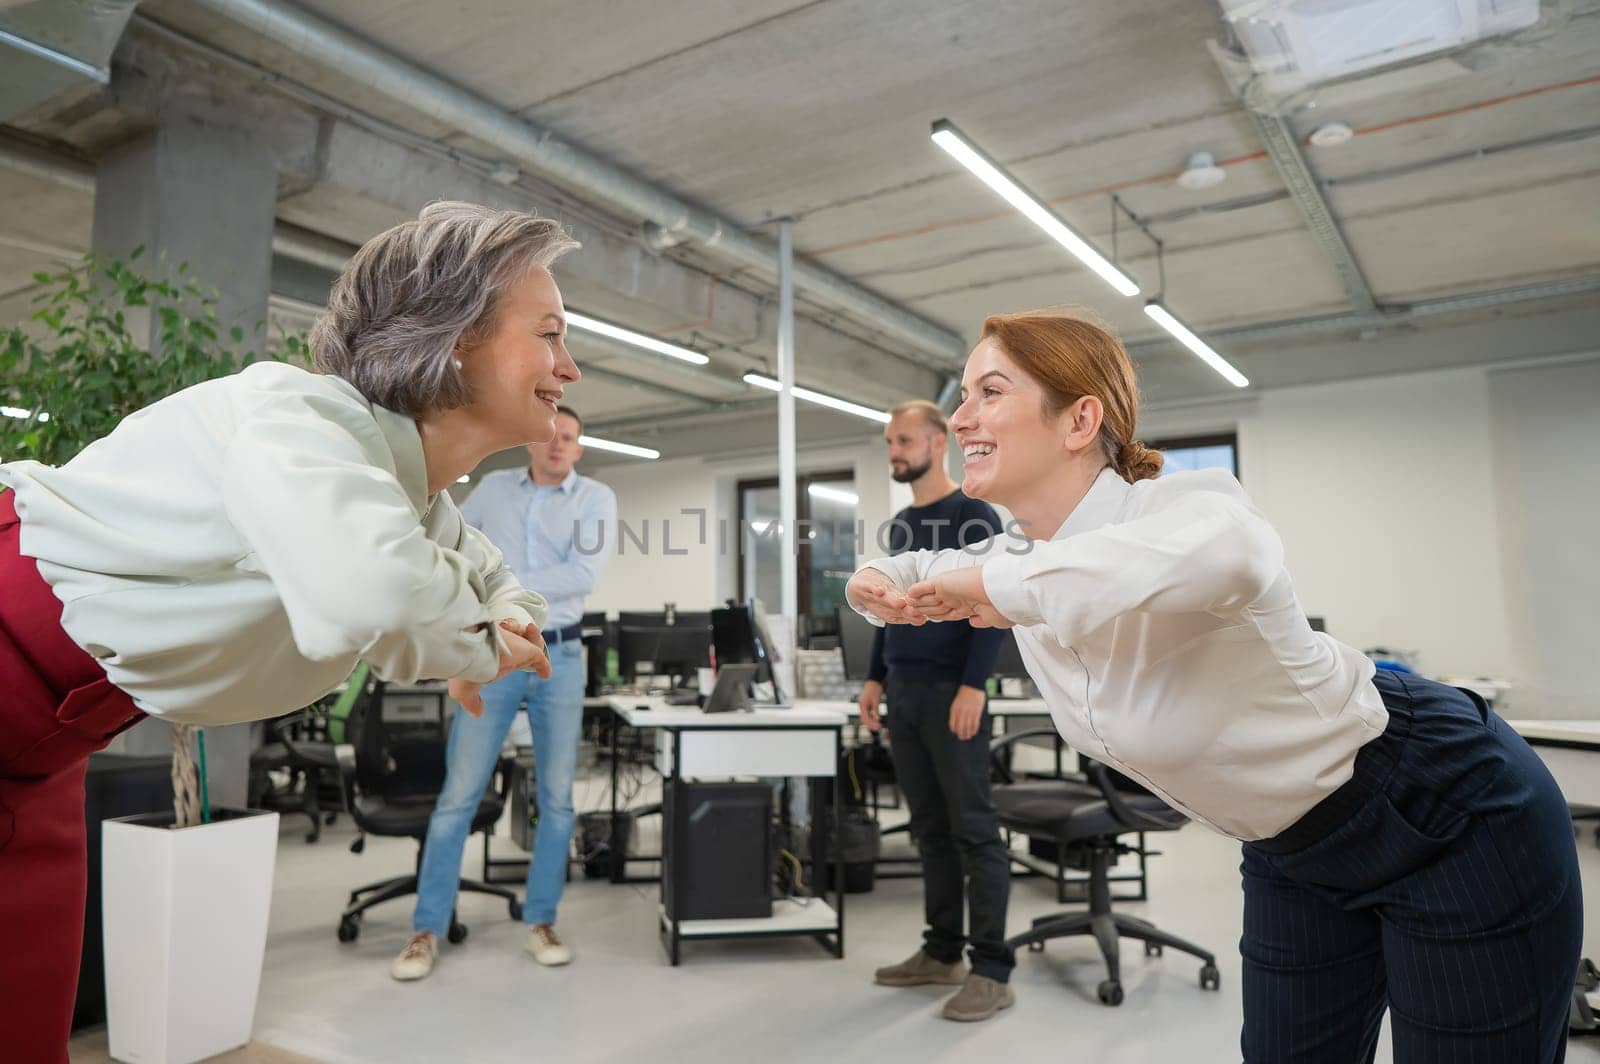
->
[862,469,1389,840]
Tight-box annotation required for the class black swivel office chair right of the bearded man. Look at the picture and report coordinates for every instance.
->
[989,728,1221,1005]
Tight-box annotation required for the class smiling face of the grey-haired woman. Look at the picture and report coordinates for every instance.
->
[456,267,581,448]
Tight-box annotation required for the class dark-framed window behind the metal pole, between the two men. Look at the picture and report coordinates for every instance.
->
[738,470,859,616]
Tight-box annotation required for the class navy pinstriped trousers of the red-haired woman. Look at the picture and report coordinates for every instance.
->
[1240,670,1582,1064]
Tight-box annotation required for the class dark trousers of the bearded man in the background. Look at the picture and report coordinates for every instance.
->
[883,669,1016,982]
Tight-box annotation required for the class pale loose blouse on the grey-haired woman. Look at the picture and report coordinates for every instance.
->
[0,363,544,725]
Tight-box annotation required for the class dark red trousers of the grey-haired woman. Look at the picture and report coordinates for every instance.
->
[0,491,144,1064]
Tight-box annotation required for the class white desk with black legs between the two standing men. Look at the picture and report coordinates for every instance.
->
[606,694,845,965]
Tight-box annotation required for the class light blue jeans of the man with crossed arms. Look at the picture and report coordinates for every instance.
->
[411,640,584,936]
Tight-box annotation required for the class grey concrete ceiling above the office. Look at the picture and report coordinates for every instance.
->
[0,0,1600,456]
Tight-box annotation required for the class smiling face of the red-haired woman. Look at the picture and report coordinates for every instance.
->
[950,338,1074,510]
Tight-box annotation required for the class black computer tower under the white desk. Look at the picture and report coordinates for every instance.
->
[661,782,773,920]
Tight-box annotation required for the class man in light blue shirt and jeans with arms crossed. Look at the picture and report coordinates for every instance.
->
[390,406,616,979]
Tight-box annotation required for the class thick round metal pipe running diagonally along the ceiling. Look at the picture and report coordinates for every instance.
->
[184,0,966,366]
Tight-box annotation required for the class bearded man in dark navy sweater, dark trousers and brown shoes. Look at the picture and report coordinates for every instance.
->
[861,400,1014,1021]
